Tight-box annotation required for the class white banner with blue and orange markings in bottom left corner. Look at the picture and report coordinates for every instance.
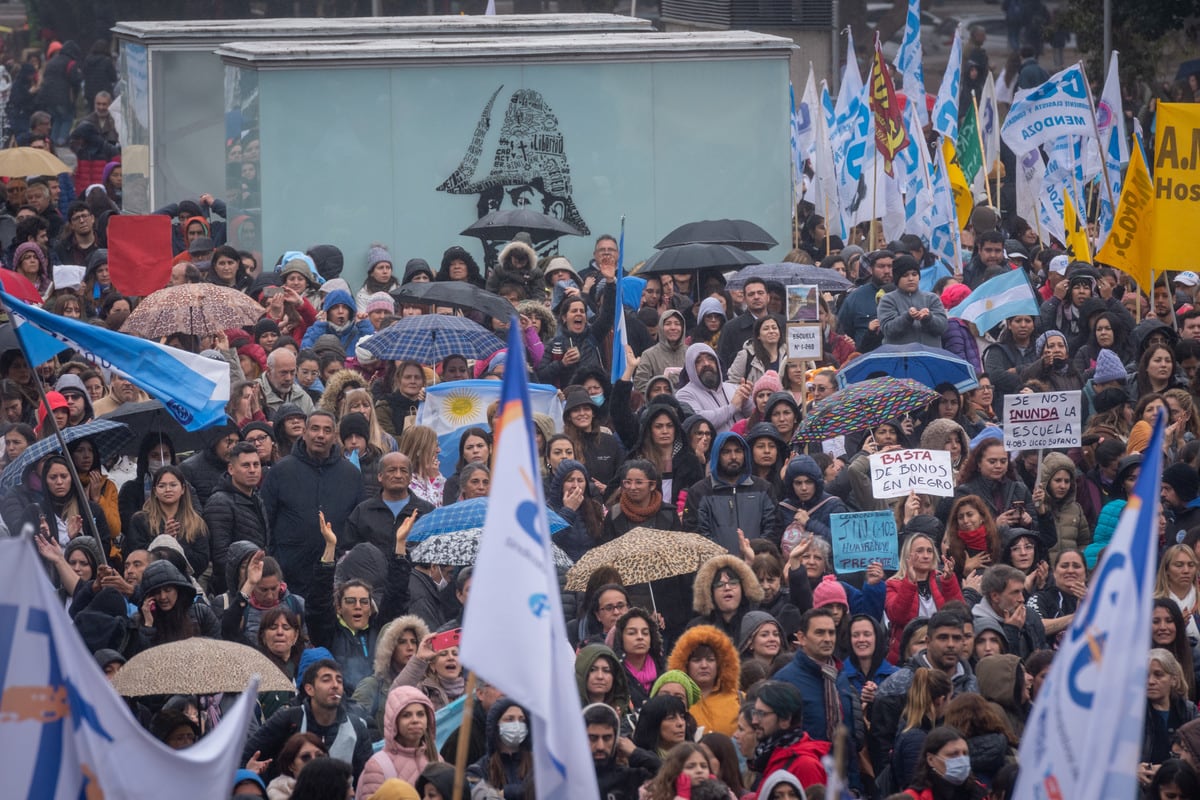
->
[0,536,258,800]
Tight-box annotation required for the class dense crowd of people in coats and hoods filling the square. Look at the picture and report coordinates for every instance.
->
[0,28,1200,800]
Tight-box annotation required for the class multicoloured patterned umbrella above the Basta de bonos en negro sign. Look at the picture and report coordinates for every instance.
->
[796,378,938,443]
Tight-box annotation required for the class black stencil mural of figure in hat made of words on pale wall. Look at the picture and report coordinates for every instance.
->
[437,85,592,270]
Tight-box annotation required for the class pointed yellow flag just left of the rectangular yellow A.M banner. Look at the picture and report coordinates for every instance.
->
[1096,140,1156,296]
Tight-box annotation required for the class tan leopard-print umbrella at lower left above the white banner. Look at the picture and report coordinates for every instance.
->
[113,637,296,697]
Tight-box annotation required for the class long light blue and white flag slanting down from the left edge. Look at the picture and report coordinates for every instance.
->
[0,291,229,431]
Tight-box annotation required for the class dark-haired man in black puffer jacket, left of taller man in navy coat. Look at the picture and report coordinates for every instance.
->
[203,441,270,594]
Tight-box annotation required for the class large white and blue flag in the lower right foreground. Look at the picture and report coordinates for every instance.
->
[1013,413,1165,800]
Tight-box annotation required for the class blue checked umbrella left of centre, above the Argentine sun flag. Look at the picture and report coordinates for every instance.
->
[360,314,504,363]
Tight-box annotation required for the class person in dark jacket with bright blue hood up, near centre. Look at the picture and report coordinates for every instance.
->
[683,432,780,557]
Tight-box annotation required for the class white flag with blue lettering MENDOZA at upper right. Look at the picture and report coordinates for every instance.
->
[1000,64,1096,152]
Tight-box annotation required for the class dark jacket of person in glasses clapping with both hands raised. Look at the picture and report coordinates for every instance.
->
[307,554,413,694]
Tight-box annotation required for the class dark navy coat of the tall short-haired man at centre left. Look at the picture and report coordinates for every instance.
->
[262,439,360,597]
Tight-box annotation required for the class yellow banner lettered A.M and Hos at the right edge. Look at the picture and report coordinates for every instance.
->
[1152,103,1200,272]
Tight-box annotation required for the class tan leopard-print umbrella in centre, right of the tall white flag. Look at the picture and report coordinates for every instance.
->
[566,528,728,591]
